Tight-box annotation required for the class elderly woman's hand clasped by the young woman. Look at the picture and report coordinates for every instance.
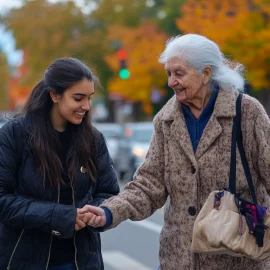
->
[79,205,106,227]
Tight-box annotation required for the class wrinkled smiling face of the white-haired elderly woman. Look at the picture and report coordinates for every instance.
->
[165,57,206,104]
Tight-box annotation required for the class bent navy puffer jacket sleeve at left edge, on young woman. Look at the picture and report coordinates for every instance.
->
[0,121,77,238]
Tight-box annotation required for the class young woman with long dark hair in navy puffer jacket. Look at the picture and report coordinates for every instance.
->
[0,58,119,270]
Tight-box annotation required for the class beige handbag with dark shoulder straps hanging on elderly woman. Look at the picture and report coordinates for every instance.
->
[191,94,270,260]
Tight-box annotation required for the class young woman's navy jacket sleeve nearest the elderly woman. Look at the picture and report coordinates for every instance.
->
[90,134,119,206]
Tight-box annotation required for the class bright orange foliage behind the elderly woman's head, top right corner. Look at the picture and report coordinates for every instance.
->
[176,0,270,90]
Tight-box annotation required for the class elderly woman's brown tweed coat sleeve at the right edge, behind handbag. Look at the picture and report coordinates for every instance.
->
[252,101,270,195]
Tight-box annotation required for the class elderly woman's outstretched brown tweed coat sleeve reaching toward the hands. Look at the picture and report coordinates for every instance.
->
[101,115,168,229]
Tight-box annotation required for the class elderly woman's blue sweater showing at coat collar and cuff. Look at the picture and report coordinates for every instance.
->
[102,87,219,230]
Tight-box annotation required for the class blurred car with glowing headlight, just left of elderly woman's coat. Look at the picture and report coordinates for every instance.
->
[116,122,154,180]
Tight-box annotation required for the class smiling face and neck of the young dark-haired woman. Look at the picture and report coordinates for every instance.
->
[50,79,95,131]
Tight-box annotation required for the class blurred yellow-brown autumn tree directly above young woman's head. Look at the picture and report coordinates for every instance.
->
[4,0,109,85]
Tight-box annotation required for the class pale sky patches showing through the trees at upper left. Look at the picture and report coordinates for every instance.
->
[0,0,95,66]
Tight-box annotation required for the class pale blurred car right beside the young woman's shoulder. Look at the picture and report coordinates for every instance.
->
[93,123,123,167]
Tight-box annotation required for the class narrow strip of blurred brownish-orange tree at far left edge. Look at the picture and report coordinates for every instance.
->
[0,51,9,111]
